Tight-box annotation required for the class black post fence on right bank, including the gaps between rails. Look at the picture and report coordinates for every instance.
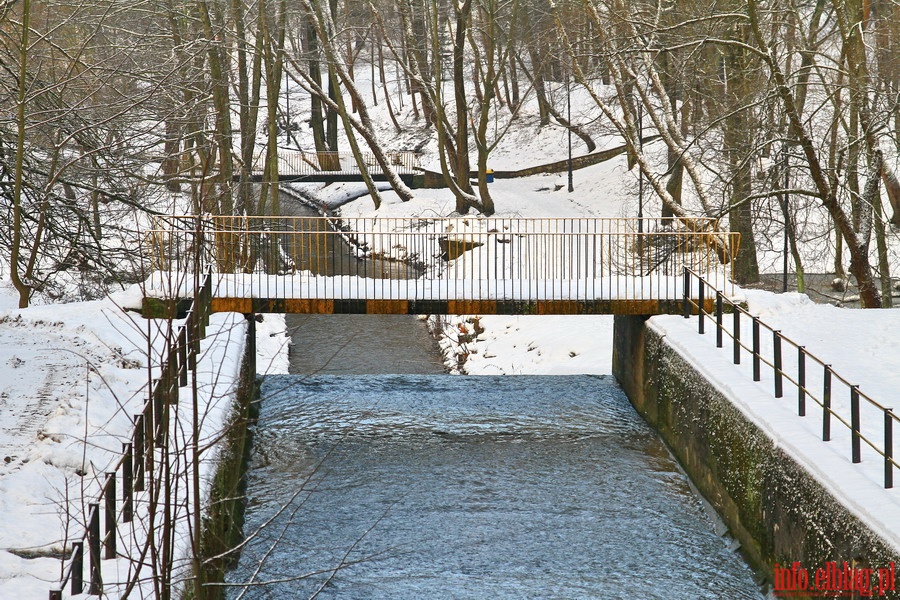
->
[682,267,898,488]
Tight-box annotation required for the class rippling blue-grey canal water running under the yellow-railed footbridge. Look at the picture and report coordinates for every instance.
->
[226,196,763,600]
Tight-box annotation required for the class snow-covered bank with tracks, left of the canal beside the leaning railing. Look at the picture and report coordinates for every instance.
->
[0,278,246,599]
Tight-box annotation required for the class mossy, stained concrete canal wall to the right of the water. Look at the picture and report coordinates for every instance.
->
[613,316,900,598]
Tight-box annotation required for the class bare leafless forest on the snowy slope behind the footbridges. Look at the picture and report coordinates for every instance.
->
[0,0,900,307]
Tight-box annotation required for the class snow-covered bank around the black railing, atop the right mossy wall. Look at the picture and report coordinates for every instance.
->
[649,292,900,552]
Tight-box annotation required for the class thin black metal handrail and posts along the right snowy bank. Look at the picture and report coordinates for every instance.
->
[682,267,900,488]
